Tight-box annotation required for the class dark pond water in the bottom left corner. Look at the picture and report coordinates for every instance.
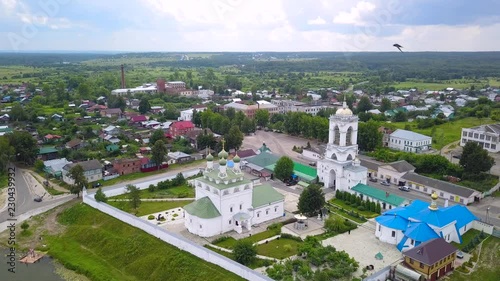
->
[0,249,64,281]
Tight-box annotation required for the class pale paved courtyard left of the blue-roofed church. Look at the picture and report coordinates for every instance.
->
[323,221,402,273]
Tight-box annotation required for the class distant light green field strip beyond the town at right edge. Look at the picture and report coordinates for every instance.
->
[391,78,500,91]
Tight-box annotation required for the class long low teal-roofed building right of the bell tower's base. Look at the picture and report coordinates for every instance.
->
[351,183,410,210]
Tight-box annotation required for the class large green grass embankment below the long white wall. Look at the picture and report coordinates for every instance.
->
[45,204,243,280]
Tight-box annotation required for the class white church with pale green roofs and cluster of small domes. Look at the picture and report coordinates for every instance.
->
[184,149,285,237]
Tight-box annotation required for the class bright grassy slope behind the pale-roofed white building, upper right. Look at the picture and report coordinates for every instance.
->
[391,117,496,149]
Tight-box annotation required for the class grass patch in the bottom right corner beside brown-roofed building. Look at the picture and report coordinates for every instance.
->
[446,236,500,281]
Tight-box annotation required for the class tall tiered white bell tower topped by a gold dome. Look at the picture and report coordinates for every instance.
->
[318,101,368,192]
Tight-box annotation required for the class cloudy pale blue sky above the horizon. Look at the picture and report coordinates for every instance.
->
[0,0,500,52]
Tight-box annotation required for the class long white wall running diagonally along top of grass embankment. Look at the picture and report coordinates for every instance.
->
[83,190,272,281]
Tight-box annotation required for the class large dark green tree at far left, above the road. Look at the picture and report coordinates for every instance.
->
[7,131,39,165]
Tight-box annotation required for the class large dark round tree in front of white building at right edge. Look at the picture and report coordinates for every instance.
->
[459,142,495,176]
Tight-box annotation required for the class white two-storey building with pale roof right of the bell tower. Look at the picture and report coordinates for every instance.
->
[388,129,432,153]
